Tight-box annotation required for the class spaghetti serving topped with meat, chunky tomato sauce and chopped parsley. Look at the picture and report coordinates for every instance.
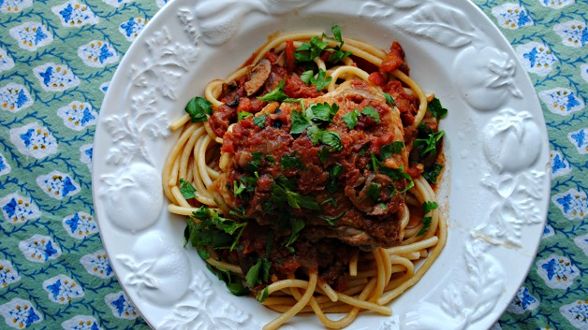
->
[163,26,447,329]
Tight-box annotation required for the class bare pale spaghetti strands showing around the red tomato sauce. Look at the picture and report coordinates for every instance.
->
[163,26,447,330]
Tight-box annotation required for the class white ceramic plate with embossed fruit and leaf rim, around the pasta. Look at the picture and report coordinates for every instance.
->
[93,0,549,329]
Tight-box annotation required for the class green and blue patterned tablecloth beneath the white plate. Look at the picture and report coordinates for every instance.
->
[0,0,588,329]
